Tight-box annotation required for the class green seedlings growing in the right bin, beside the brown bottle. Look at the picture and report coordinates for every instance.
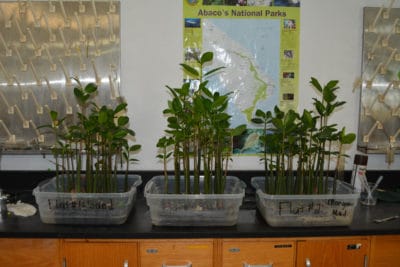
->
[252,78,356,194]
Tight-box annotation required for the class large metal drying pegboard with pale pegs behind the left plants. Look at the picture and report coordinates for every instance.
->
[0,0,120,153]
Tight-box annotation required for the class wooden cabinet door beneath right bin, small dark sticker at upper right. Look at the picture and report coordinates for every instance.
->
[296,237,369,267]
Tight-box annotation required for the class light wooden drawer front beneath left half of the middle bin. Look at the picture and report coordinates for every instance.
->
[139,239,214,267]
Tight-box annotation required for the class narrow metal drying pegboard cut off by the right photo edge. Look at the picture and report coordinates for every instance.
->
[358,5,400,164]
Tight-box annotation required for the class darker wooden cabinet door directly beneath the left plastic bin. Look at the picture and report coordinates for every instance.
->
[62,239,137,267]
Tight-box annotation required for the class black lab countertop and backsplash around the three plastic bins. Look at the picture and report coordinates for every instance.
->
[0,172,400,239]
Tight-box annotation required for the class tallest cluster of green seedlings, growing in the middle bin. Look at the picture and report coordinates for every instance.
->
[157,52,246,194]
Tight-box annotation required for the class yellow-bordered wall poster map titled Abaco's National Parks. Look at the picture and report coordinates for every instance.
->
[183,0,300,154]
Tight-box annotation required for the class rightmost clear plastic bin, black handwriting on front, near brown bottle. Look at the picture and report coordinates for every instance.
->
[251,177,360,227]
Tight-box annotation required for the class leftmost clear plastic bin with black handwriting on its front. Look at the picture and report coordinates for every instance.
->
[33,175,142,224]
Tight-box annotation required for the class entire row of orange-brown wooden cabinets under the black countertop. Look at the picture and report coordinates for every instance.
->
[0,235,400,267]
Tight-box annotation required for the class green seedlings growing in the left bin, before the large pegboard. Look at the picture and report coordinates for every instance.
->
[40,79,141,193]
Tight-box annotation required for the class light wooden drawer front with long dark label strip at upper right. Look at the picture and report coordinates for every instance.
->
[222,239,296,267]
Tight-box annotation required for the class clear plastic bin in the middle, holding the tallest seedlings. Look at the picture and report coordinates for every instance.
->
[144,176,246,226]
